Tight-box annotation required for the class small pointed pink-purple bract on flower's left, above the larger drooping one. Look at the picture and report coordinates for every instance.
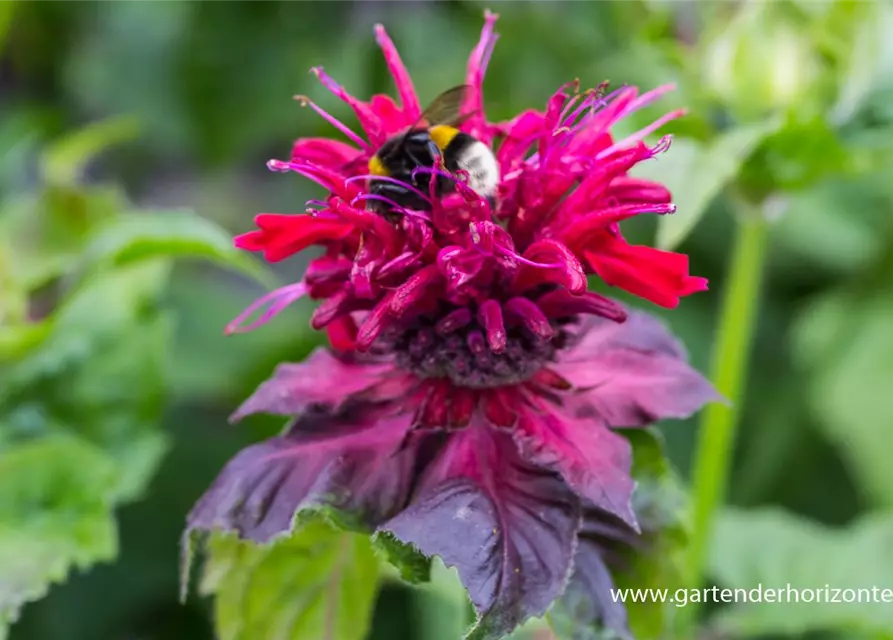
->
[231,348,393,421]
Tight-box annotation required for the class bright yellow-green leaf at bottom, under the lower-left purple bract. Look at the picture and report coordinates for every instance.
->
[201,519,379,640]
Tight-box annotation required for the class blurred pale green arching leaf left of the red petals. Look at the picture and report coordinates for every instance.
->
[83,211,276,287]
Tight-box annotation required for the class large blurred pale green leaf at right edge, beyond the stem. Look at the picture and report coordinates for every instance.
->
[794,286,893,506]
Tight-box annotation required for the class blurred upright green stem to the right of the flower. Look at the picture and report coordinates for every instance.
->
[684,214,767,624]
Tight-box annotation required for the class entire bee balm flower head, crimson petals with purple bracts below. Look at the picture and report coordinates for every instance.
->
[190,13,715,637]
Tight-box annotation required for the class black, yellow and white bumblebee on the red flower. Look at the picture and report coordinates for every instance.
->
[368,85,499,218]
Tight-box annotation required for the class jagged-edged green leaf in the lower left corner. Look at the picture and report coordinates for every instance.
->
[0,436,117,634]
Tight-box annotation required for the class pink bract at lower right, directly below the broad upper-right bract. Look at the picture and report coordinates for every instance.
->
[514,397,638,528]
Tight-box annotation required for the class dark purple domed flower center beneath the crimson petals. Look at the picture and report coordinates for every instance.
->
[394,318,562,389]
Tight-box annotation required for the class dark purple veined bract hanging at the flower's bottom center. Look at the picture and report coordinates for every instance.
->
[382,424,580,640]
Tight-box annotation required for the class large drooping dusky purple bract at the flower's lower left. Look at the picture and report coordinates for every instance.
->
[186,411,416,542]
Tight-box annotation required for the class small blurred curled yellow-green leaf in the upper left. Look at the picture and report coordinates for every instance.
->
[41,117,140,186]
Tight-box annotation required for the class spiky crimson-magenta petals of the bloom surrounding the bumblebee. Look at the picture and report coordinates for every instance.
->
[236,14,707,340]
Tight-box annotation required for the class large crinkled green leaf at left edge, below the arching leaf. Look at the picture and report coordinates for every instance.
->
[0,260,172,504]
